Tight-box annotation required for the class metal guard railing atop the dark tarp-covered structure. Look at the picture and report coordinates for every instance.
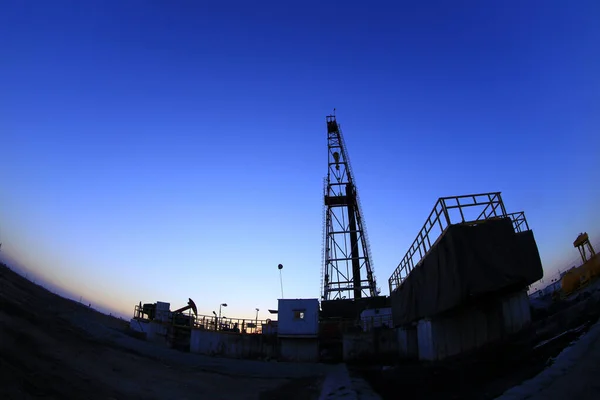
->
[388,192,529,294]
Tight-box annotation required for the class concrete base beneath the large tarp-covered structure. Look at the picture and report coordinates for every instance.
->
[412,291,531,361]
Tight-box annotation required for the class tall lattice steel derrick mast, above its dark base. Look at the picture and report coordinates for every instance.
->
[322,115,378,300]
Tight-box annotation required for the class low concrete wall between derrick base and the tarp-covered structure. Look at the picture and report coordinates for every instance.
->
[342,329,398,362]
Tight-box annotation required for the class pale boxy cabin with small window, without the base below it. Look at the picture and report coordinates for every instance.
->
[277,299,319,336]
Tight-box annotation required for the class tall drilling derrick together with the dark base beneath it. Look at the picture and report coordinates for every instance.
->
[319,109,382,360]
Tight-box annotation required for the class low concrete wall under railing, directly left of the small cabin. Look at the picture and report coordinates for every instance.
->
[190,329,278,358]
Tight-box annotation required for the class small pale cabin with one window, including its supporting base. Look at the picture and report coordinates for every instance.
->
[277,299,319,362]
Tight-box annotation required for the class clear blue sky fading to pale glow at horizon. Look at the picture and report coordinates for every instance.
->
[0,0,600,318]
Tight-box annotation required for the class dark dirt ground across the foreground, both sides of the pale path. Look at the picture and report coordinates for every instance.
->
[5,264,600,400]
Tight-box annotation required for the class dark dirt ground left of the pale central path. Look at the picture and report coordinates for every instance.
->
[0,265,327,399]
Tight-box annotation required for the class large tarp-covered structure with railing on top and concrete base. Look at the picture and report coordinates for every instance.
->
[389,193,543,361]
